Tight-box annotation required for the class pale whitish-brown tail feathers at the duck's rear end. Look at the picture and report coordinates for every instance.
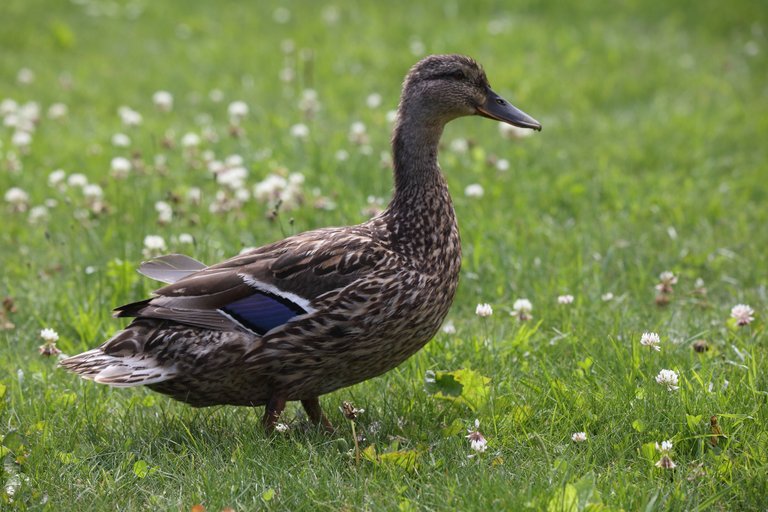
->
[59,348,178,387]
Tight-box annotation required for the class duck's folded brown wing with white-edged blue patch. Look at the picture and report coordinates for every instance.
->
[115,228,392,335]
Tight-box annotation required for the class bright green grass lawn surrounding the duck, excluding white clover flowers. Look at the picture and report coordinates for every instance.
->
[0,0,768,510]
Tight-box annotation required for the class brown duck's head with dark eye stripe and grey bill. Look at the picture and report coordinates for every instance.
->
[400,55,541,130]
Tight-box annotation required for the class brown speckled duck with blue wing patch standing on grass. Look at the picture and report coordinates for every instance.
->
[59,54,541,432]
